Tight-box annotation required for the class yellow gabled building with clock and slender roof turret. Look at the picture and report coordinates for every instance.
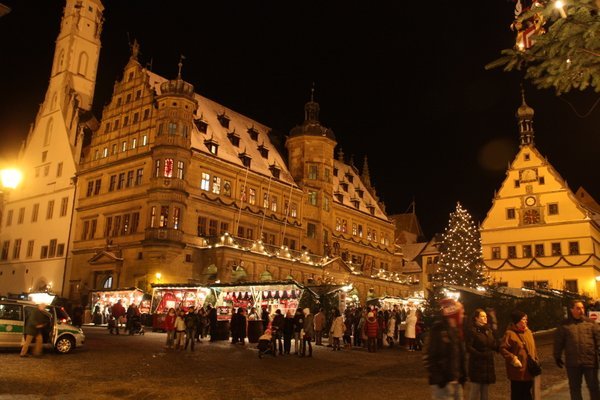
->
[480,93,600,297]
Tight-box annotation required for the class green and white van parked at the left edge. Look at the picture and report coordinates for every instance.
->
[0,300,85,354]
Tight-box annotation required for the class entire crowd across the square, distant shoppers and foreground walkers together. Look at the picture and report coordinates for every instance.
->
[91,298,600,400]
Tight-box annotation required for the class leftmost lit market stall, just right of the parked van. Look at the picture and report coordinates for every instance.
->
[85,287,150,325]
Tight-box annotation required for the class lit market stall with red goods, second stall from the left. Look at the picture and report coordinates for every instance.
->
[150,284,211,331]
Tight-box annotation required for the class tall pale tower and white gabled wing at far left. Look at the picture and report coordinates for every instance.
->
[0,0,104,294]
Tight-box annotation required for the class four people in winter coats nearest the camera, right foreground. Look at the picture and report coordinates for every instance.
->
[423,298,600,400]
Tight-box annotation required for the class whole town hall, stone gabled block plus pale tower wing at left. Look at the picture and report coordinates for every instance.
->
[0,0,414,300]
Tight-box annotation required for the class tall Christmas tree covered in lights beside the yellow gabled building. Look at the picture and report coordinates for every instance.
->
[438,203,485,288]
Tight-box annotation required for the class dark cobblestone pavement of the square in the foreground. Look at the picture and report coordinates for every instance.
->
[0,327,565,400]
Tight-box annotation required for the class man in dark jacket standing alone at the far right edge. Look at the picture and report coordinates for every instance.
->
[554,300,600,400]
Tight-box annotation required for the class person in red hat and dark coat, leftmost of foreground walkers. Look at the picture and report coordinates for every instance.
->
[423,298,467,400]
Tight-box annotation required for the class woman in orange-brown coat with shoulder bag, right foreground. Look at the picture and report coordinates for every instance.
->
[500,310,541,400]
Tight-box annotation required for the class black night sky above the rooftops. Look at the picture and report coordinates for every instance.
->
[0,0,600,237]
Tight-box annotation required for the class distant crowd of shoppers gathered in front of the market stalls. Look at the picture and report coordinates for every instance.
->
[155,305,424,357]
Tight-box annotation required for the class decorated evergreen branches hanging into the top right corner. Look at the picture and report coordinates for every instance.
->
[485,0,600,95]
